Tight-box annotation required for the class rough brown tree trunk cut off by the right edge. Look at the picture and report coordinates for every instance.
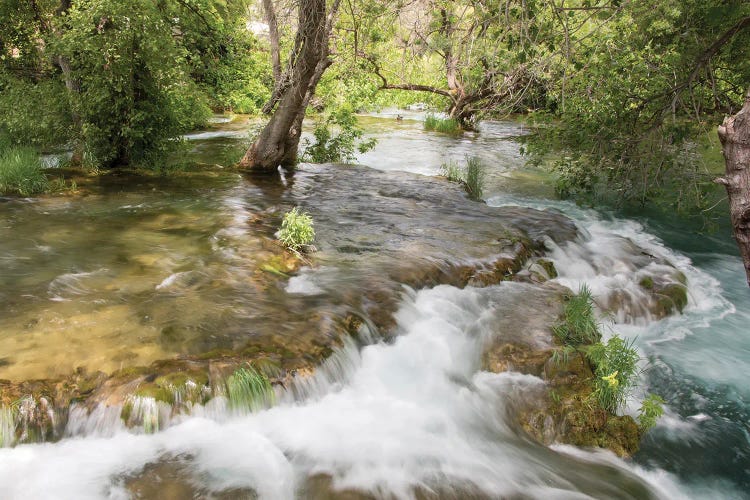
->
[716,91,750,285]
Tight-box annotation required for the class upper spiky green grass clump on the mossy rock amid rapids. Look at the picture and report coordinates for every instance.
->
[552,285,602,348]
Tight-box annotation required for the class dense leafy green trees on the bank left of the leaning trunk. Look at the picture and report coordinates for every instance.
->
[0,0,258,167]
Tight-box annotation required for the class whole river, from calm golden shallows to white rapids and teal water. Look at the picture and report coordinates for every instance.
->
[0,114,750,499]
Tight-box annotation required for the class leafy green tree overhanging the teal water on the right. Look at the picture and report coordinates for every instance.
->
[525,0,750,214]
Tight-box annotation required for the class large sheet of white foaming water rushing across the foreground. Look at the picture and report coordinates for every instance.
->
[0,283,688,499]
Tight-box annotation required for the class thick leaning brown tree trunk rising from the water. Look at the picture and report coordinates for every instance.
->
[239,0,329,172]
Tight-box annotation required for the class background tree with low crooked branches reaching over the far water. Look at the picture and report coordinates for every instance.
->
[356,0,554,128]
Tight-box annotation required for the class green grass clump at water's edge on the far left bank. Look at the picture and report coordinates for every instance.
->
[0,146,49,196]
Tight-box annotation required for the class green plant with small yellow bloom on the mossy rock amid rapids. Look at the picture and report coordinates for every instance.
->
[588,335,640,413]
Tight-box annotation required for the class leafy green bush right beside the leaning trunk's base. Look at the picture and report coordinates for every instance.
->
[302,105,377,163]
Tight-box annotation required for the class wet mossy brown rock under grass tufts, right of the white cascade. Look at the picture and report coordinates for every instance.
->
[482,283,641,456]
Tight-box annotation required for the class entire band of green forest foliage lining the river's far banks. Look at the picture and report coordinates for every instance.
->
[0,0,750,212]
